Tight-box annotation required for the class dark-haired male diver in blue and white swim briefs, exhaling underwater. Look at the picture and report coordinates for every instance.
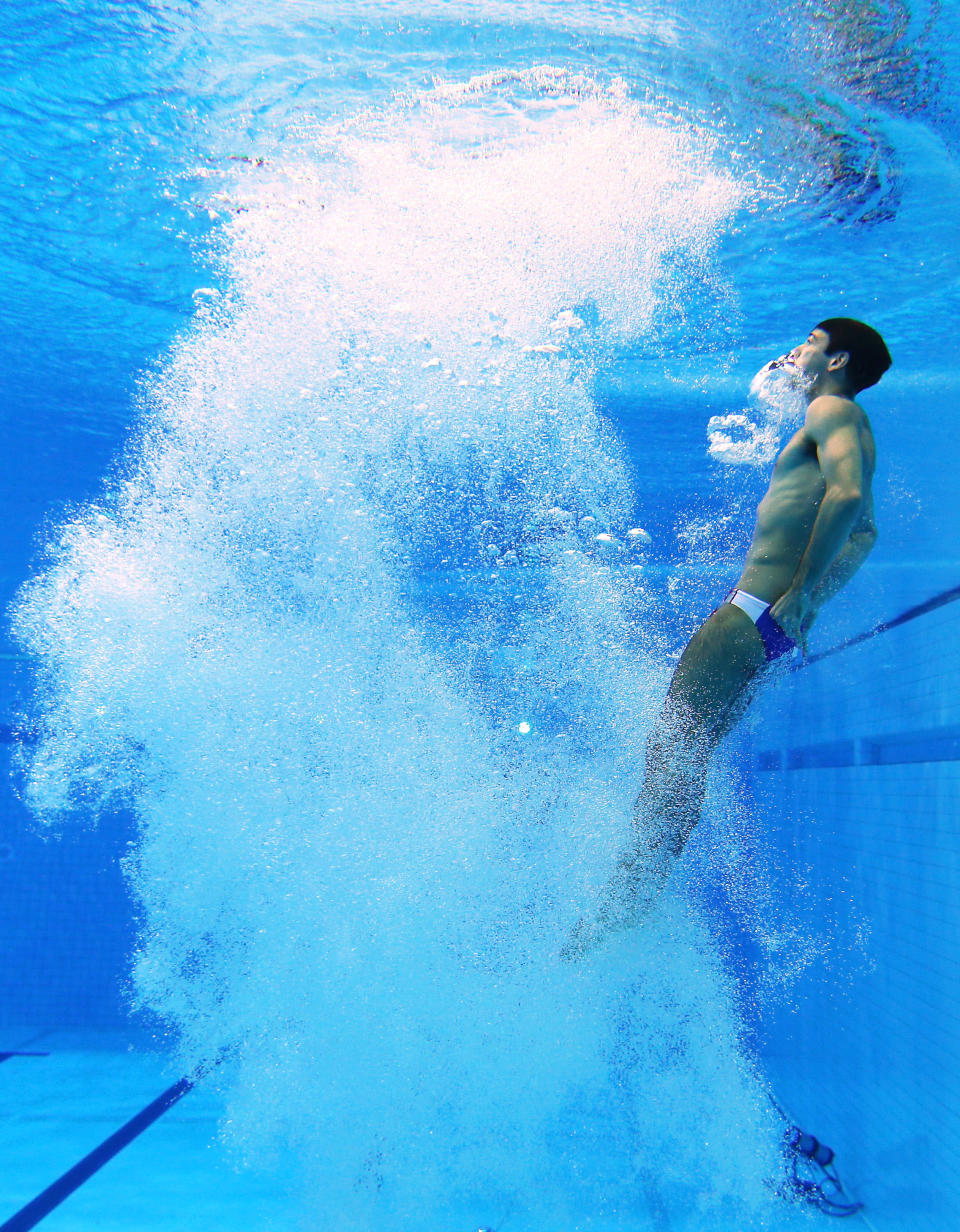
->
[563,317,891,958]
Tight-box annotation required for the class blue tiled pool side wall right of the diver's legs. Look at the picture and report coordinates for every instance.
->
[741,588,960,1232]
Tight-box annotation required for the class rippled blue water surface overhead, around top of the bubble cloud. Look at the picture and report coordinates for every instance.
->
[0,0,956,409]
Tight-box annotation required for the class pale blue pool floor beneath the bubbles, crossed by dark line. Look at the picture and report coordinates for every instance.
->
[0,1030,857,1232]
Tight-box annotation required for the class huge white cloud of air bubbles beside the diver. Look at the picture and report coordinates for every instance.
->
[16,70,774,1230]
